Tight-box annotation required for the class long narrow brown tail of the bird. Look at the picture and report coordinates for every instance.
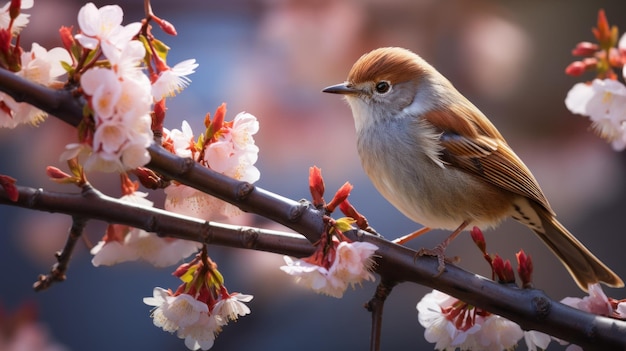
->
[532,204,624,291]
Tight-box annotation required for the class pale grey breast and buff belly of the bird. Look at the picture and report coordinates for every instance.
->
[357,121,513,230]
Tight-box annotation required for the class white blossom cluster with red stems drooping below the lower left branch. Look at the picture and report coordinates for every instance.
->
[143,252,253,350]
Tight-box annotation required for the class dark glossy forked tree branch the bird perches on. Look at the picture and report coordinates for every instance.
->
[0,66,626,349]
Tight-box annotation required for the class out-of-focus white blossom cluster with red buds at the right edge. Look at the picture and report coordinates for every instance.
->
[565,11,626,150]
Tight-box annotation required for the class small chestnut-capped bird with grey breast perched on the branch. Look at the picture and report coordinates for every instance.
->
[322,47,624,291]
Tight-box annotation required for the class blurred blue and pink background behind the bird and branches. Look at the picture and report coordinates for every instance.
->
[0,0,626,351]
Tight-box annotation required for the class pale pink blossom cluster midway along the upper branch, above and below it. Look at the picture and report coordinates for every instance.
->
[163,104,260,220]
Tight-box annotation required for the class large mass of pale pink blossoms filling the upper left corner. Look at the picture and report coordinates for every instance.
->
[0,0,198,172]
